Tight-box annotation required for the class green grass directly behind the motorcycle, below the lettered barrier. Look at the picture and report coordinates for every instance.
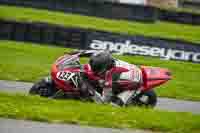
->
[0,41,200,101]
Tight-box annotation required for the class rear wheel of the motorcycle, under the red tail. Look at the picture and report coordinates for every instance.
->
[134,90,157,107]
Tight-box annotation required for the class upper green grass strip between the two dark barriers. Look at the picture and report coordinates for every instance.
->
[0,6,200,43]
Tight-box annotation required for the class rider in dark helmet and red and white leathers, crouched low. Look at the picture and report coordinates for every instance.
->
[79,51,142,103]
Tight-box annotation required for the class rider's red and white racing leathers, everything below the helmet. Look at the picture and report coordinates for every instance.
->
[81,59,142,103]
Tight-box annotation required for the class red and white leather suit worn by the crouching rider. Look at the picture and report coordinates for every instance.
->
[84,59,142,103]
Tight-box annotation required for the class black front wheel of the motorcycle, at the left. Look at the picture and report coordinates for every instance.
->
[29,78,55,97]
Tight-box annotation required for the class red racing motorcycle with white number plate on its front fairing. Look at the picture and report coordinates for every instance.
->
[29,50,172,107]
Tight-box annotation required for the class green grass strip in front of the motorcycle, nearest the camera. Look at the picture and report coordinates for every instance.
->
[0,93,200,133]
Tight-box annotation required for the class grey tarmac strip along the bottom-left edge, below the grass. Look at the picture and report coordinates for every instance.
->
[0,118,155,133]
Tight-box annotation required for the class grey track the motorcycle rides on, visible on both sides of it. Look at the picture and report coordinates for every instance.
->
[0,80,200,114]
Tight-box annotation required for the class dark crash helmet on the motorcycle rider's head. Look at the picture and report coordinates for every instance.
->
[89,51,113,74]
